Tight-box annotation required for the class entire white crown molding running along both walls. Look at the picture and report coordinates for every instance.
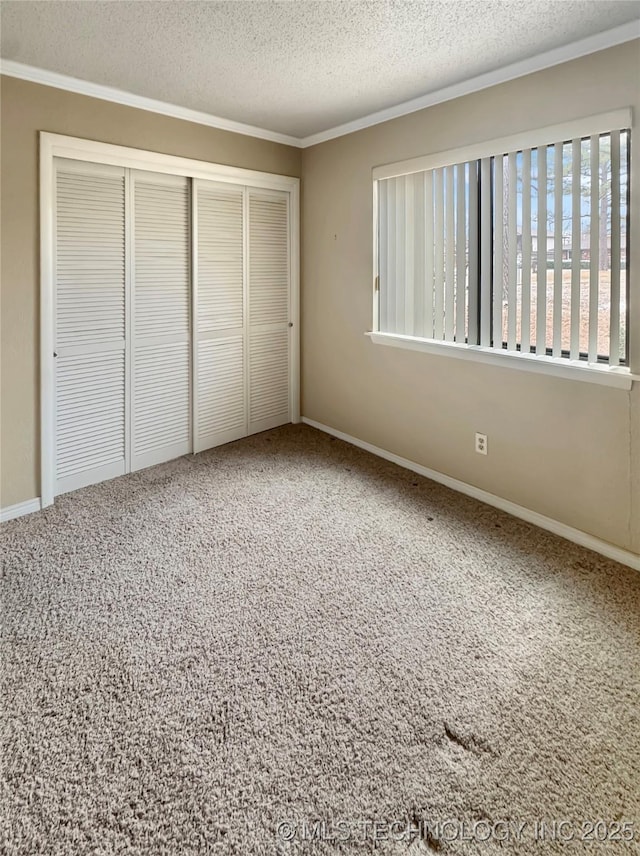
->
[0,20,640,149]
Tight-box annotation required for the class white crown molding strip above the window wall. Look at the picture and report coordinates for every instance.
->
[300,21,640,148]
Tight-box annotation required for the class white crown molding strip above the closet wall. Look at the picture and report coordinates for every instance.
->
[0,59,300,148]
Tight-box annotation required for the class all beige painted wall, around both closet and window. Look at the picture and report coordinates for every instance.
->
[0,42,640,553]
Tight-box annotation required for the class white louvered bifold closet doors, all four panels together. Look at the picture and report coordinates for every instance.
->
[52,157,292,494]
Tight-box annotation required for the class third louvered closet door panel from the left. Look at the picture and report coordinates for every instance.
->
[193,180,247,452]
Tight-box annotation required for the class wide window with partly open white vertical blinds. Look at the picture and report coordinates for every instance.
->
[373,110,631,382]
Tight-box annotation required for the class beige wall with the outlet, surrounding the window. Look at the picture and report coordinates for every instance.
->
[302,42,640,553]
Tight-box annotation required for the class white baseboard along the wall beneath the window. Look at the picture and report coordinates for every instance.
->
[302,416,640,571]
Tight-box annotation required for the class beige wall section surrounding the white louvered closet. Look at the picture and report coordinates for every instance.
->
[0,77,301,508]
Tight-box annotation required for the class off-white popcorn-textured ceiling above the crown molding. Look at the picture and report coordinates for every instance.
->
[0,0,640,137]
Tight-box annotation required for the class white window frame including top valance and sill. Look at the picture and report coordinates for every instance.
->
[367,107,640,390]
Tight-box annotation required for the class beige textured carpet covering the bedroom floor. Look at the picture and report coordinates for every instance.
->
[0,426,640,856]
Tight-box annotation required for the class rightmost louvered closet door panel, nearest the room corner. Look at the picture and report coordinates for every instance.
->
[247,188,291,434]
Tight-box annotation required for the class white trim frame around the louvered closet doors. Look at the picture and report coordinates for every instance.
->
[39,131,300,508]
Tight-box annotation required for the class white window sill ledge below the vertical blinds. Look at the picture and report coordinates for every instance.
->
[365,332,640,390]
